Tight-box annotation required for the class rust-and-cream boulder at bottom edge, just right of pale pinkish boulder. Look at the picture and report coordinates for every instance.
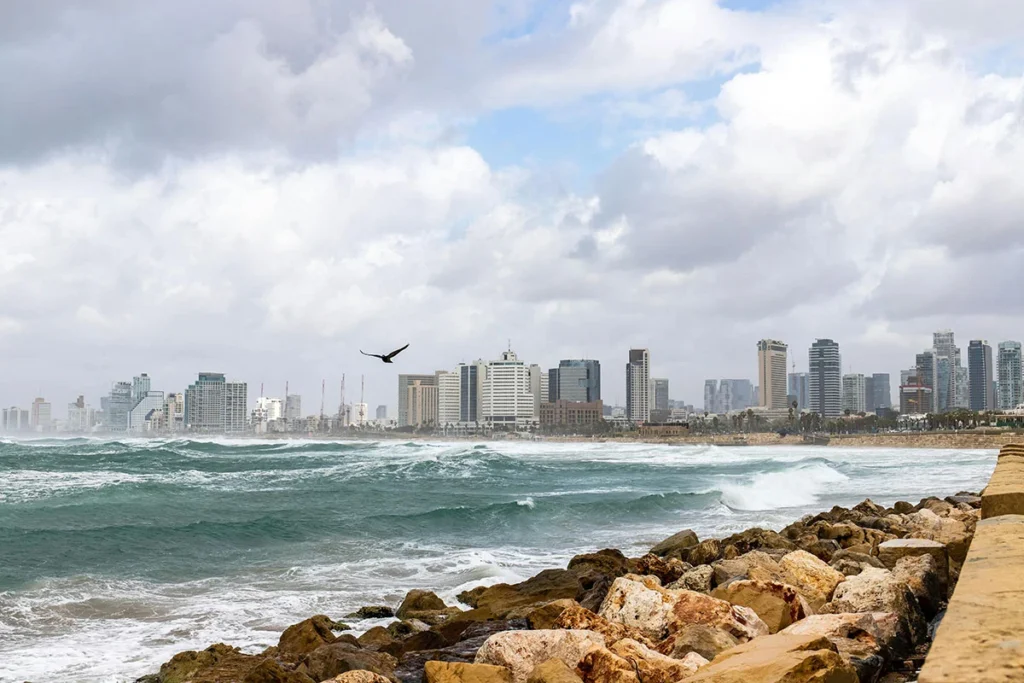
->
[577,640,694,683]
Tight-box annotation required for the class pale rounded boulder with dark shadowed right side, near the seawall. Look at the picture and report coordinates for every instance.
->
[819,567,927,644]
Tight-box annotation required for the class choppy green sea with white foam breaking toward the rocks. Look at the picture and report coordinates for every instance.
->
[0,438,996,683]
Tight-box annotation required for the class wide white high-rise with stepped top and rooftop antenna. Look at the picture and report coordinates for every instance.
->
[479,349,541,427]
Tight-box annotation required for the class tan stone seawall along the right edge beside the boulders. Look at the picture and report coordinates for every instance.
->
[919,443,1024,683]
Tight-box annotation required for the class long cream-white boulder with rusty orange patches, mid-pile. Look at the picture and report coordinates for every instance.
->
[600,577,768,641]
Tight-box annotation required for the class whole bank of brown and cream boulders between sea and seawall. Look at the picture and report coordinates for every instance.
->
[140,494,981,683]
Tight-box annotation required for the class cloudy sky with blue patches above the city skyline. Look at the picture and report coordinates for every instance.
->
[0,0,1024,417]
